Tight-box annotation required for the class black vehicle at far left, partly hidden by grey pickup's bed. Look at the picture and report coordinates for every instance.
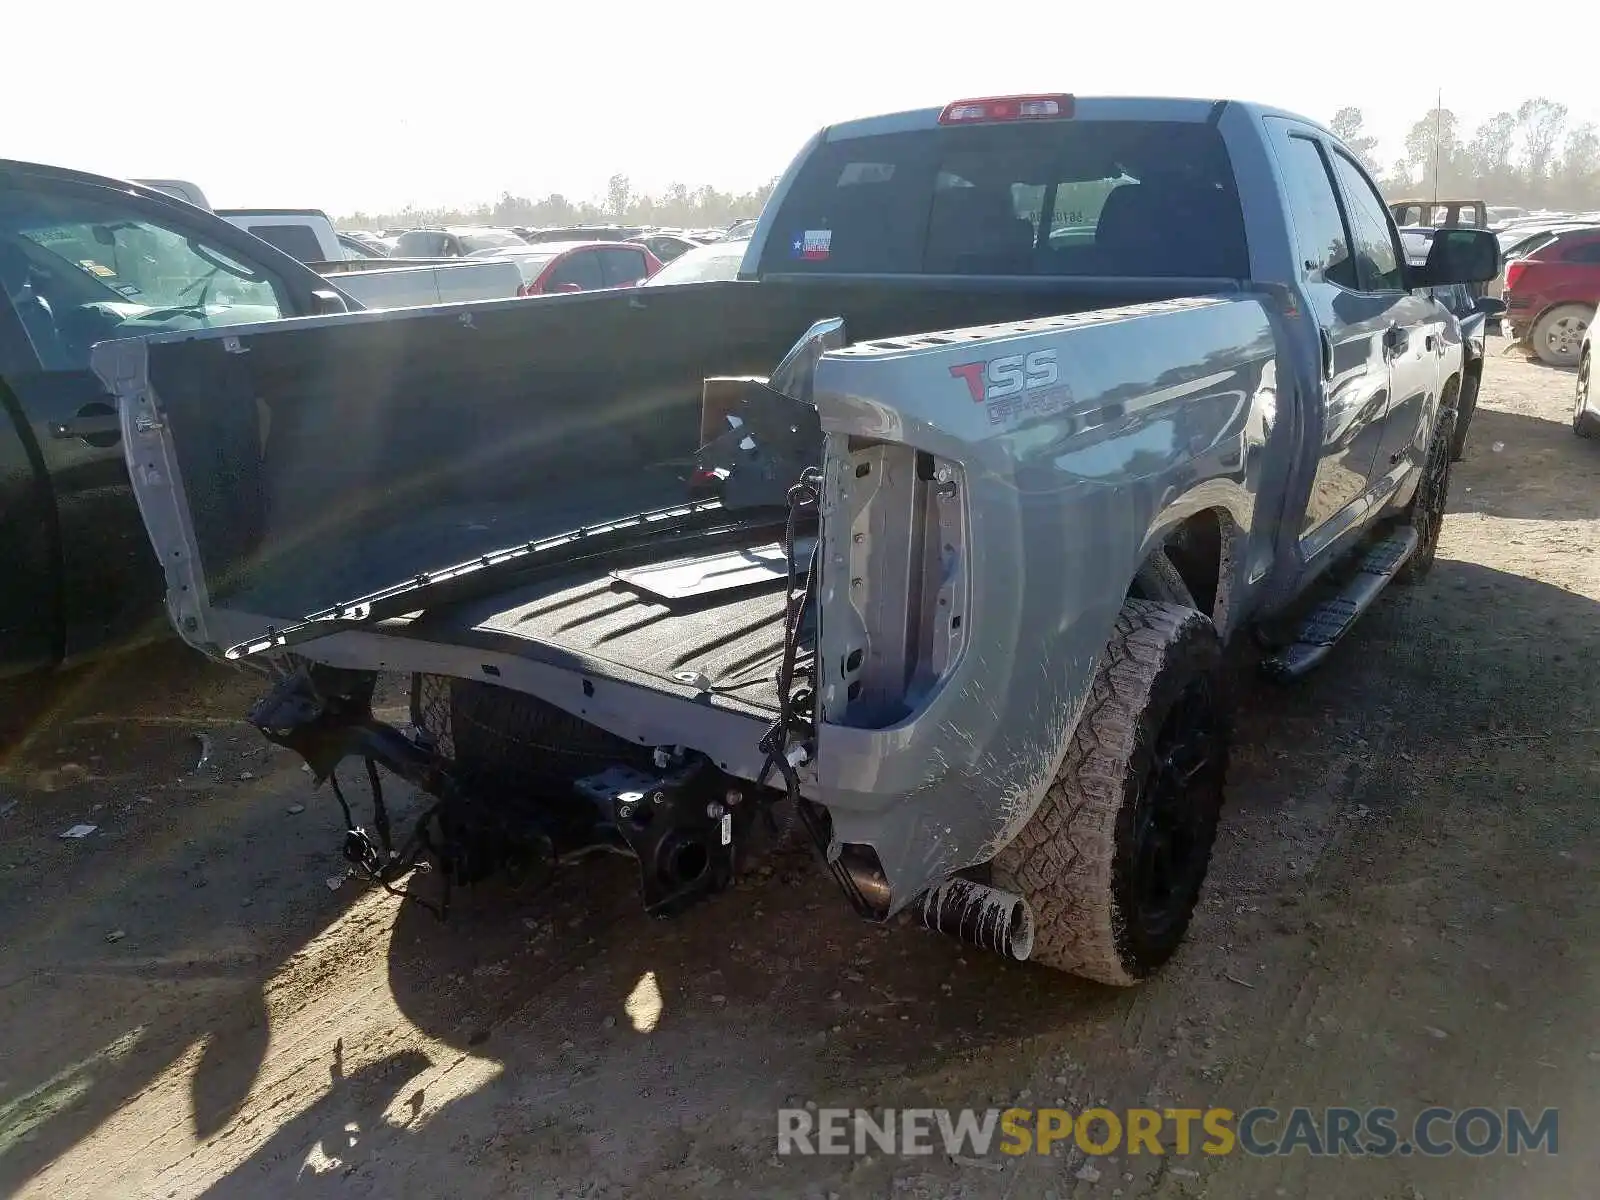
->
[0,160,360,675]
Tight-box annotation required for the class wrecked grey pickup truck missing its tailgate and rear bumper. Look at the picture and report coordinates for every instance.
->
[94,96,1499,984]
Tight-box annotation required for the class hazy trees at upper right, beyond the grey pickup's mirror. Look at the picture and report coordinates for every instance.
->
[1330,96,1600,211]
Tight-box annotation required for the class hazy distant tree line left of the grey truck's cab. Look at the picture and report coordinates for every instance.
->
[338,174,778,229]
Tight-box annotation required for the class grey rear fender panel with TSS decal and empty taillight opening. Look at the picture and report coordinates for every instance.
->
[816,296,1277,910]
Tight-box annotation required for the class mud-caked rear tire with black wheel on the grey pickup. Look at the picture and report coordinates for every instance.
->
[990,600,1229,987]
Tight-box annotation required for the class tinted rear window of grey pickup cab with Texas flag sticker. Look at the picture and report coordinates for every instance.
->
[760,120,1250,278]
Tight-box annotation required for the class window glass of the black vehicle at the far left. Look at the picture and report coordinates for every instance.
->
[0,194,280,309]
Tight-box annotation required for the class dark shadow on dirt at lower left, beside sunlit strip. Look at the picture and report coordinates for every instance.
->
[0,643,384,1194]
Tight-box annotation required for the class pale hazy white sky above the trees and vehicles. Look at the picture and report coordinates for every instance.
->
[0,0,1600,213]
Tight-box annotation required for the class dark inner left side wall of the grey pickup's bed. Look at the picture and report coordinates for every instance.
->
[93,283,803,654]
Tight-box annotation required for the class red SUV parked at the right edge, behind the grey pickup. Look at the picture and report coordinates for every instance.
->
[1506,226,1600,366]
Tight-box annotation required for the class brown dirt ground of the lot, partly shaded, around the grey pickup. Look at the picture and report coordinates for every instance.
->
[0,347,1600,1200]
